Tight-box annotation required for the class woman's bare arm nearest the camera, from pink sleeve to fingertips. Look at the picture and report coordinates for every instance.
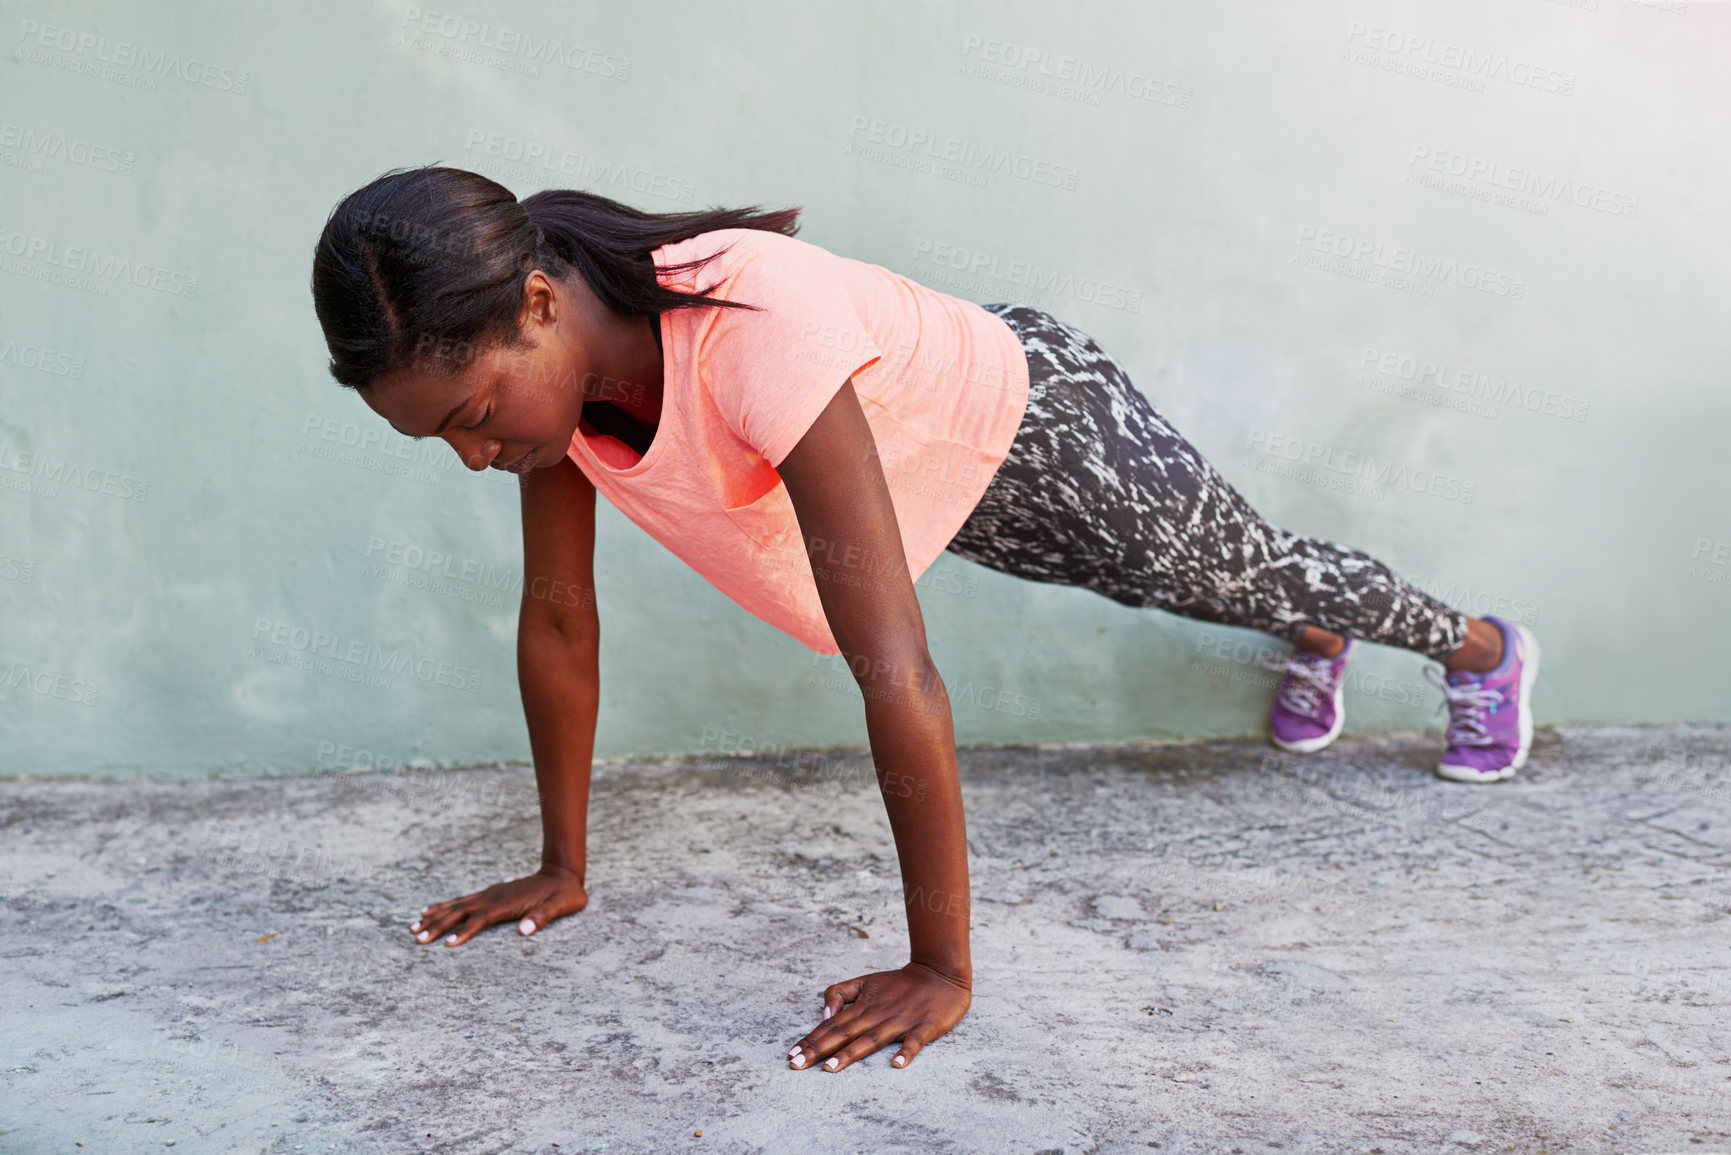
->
[777,381,973,1070]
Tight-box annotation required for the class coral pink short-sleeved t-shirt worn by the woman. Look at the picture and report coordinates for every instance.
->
[569,229,1028,655]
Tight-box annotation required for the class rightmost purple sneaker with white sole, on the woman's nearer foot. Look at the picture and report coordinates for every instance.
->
[1426,615,1539,783]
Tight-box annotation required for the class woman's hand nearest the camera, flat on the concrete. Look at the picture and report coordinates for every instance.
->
[788,963,973,1070]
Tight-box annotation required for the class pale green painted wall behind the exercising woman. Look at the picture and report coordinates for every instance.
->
[0,0,1731,776]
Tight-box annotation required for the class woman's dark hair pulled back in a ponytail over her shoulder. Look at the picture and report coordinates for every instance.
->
[312,166,800,388]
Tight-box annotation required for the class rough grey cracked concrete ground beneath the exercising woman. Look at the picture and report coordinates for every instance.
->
[0,727,1731,1155]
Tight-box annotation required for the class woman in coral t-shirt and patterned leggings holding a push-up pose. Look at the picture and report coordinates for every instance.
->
[312,168,1539,1070]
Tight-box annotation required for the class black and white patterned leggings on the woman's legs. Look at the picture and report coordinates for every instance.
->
[949,305,1466,661]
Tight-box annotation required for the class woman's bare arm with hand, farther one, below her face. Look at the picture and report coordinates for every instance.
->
[410,459,601,947]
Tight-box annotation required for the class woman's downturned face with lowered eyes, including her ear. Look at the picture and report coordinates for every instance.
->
[360,272,597,473]
